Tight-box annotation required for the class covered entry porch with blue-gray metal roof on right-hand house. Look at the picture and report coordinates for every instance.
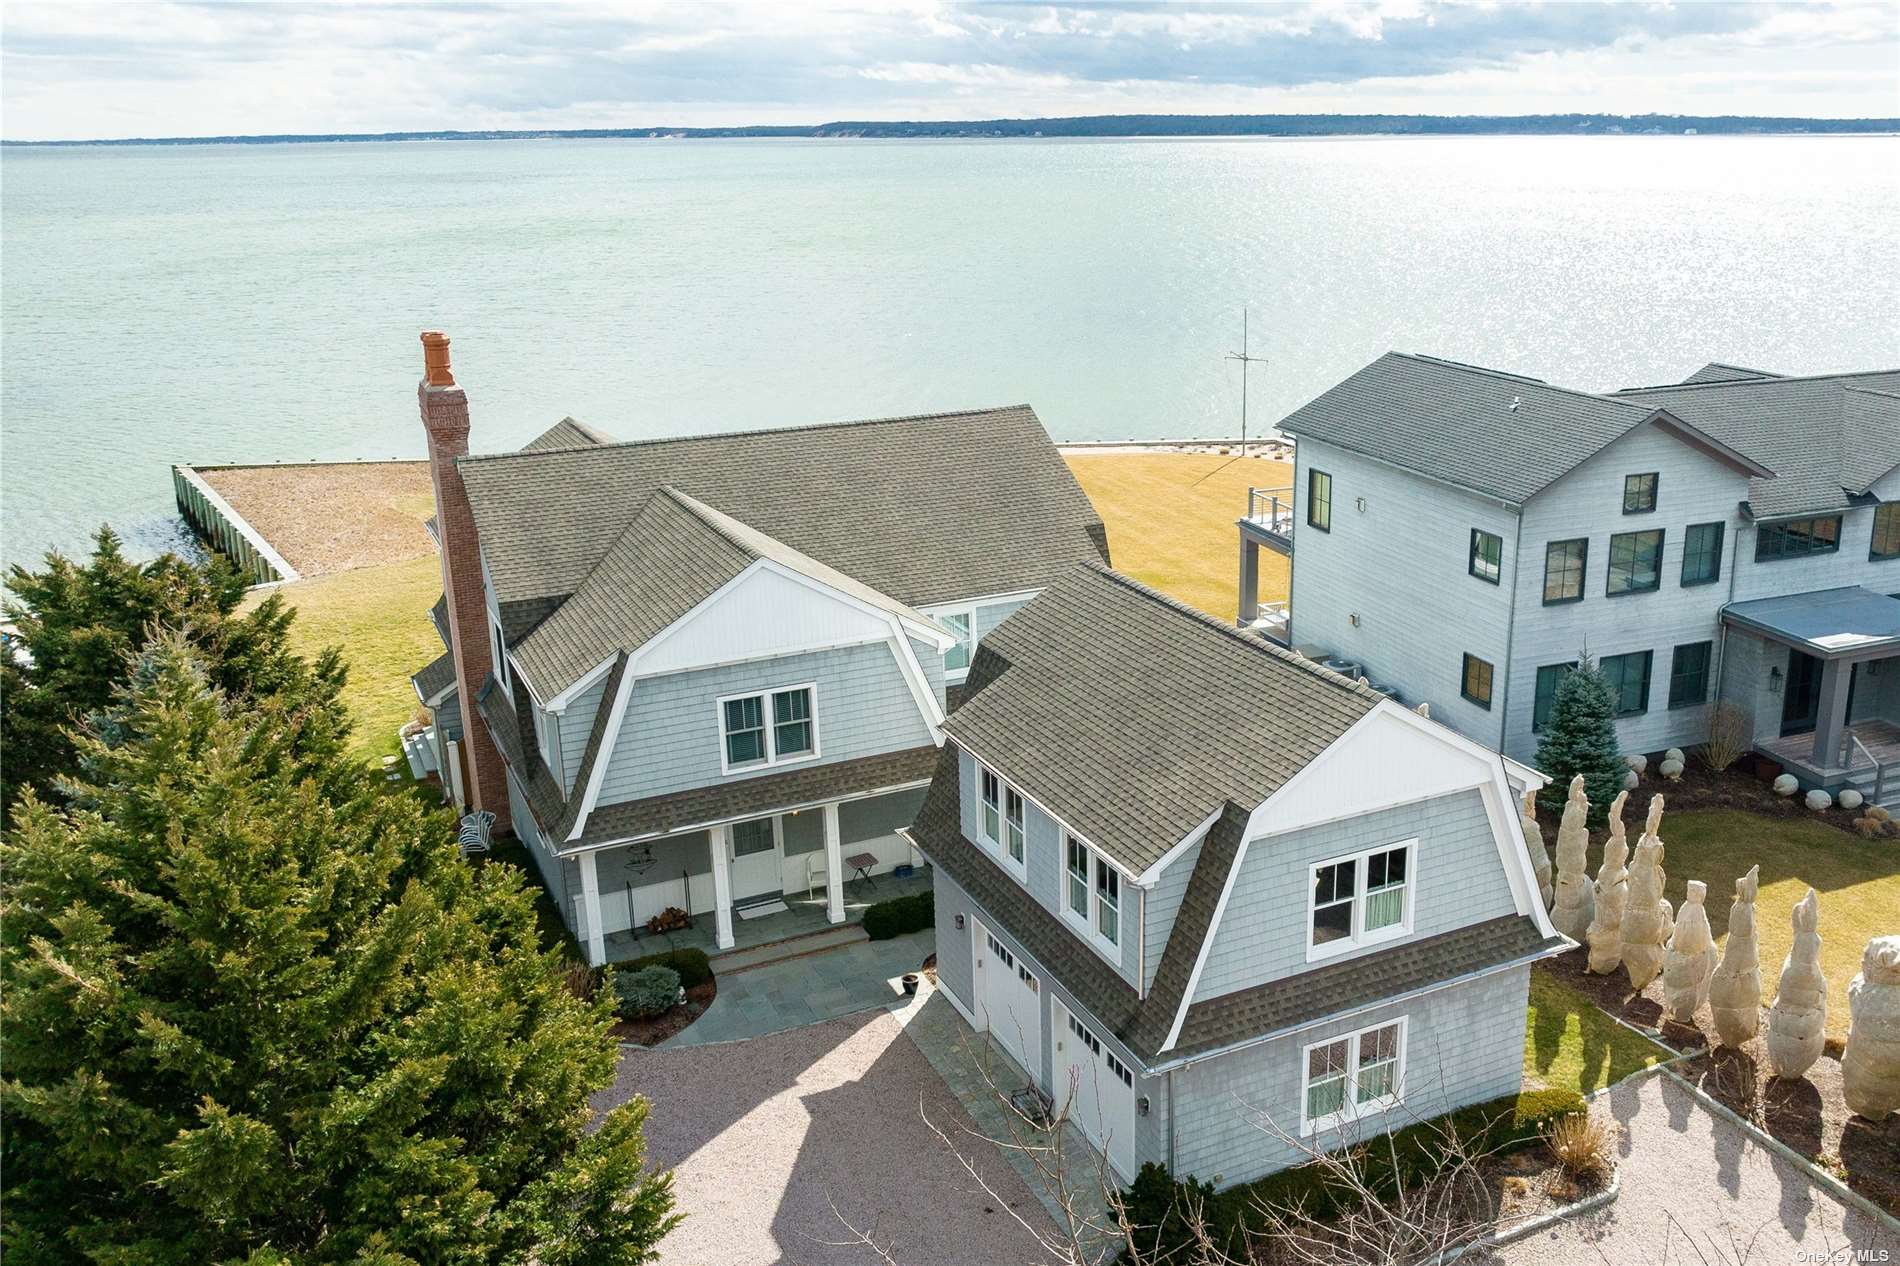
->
[1721,585,1900,804]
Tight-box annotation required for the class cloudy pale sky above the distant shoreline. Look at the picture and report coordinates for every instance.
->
[0,0,1900,141]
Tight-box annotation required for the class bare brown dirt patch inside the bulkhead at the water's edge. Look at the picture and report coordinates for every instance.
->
[198,462,435,576]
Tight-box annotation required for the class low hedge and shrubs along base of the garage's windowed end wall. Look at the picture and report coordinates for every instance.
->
[1123,1089,1585,1262]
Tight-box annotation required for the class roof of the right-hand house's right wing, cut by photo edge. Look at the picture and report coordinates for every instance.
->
[1617,371,1900,519]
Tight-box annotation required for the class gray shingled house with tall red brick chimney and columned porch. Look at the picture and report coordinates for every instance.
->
[414,335,1108,964]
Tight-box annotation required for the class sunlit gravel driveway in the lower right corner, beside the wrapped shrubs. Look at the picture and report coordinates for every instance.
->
[1492,1074,1900,1266]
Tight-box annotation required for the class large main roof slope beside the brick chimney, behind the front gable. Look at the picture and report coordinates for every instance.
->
[460,405,1106,606]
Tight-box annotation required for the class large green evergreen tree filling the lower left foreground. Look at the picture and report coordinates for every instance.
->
[0,634,676,1266]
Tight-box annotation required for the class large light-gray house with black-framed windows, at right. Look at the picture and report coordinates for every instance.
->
[1239,352,1900,802]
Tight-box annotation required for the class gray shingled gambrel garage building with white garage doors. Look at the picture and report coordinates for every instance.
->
[908,565,1569,1186]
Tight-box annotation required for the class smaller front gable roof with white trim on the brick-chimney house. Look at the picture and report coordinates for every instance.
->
[515,487,946,700]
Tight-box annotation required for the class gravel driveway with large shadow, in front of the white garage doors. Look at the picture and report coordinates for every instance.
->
[595,1011,1049,1266]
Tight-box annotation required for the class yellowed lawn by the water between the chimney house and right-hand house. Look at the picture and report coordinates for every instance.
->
[1068,452,1294,620]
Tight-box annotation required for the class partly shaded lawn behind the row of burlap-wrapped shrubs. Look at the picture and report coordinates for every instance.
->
[1590,809,1900,1038]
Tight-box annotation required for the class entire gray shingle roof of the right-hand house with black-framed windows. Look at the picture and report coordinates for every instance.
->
[1281,352,1900,519]
